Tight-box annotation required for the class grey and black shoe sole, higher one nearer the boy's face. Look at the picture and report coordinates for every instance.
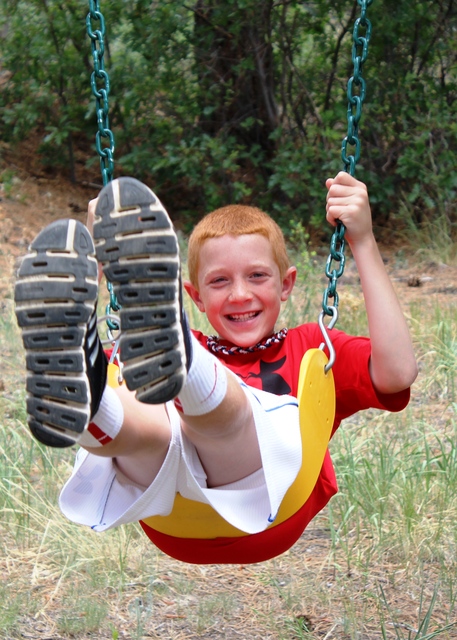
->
[94,178,188,404]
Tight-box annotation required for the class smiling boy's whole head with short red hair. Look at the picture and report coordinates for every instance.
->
[185,211,297,347]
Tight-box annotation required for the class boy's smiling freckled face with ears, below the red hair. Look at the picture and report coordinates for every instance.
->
[184,234,296,347]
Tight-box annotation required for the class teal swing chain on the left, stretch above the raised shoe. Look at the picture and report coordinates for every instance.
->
[86,0,114,185]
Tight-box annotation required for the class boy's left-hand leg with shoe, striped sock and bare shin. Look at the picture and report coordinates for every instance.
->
[14,220,170,471]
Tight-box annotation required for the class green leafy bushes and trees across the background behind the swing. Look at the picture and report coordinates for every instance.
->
[0,0,457,237]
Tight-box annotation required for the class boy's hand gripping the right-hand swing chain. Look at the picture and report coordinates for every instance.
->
[325,171,372,246]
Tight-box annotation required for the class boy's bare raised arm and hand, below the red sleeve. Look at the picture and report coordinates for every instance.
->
[326,171,417,393]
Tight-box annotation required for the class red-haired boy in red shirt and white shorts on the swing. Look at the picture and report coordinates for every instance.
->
[15,172,417,562]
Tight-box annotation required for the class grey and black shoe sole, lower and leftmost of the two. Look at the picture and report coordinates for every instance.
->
[14,220,98,447]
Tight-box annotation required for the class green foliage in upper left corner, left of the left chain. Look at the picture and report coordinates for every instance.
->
[0,0,93,178]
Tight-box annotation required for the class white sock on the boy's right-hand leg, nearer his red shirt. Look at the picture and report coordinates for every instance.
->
[175,335,227,416]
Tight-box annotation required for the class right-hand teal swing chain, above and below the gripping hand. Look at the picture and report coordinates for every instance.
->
[322,0,373,316]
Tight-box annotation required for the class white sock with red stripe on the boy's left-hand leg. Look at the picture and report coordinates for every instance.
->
[78,385,124,447]
